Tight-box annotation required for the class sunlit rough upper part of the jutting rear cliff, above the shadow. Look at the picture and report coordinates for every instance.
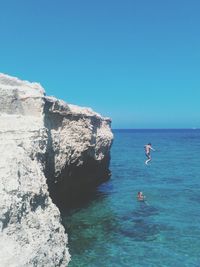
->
[46,97,113,182]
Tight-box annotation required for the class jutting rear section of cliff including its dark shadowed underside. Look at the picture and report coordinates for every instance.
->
[45,97,113,206]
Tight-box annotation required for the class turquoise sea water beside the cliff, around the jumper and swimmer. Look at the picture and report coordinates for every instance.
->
[63,130,200,267]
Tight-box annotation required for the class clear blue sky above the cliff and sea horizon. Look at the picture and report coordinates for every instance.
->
[0,0,200,128]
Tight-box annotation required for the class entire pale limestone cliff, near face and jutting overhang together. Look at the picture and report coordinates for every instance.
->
[0,74,113,267]
